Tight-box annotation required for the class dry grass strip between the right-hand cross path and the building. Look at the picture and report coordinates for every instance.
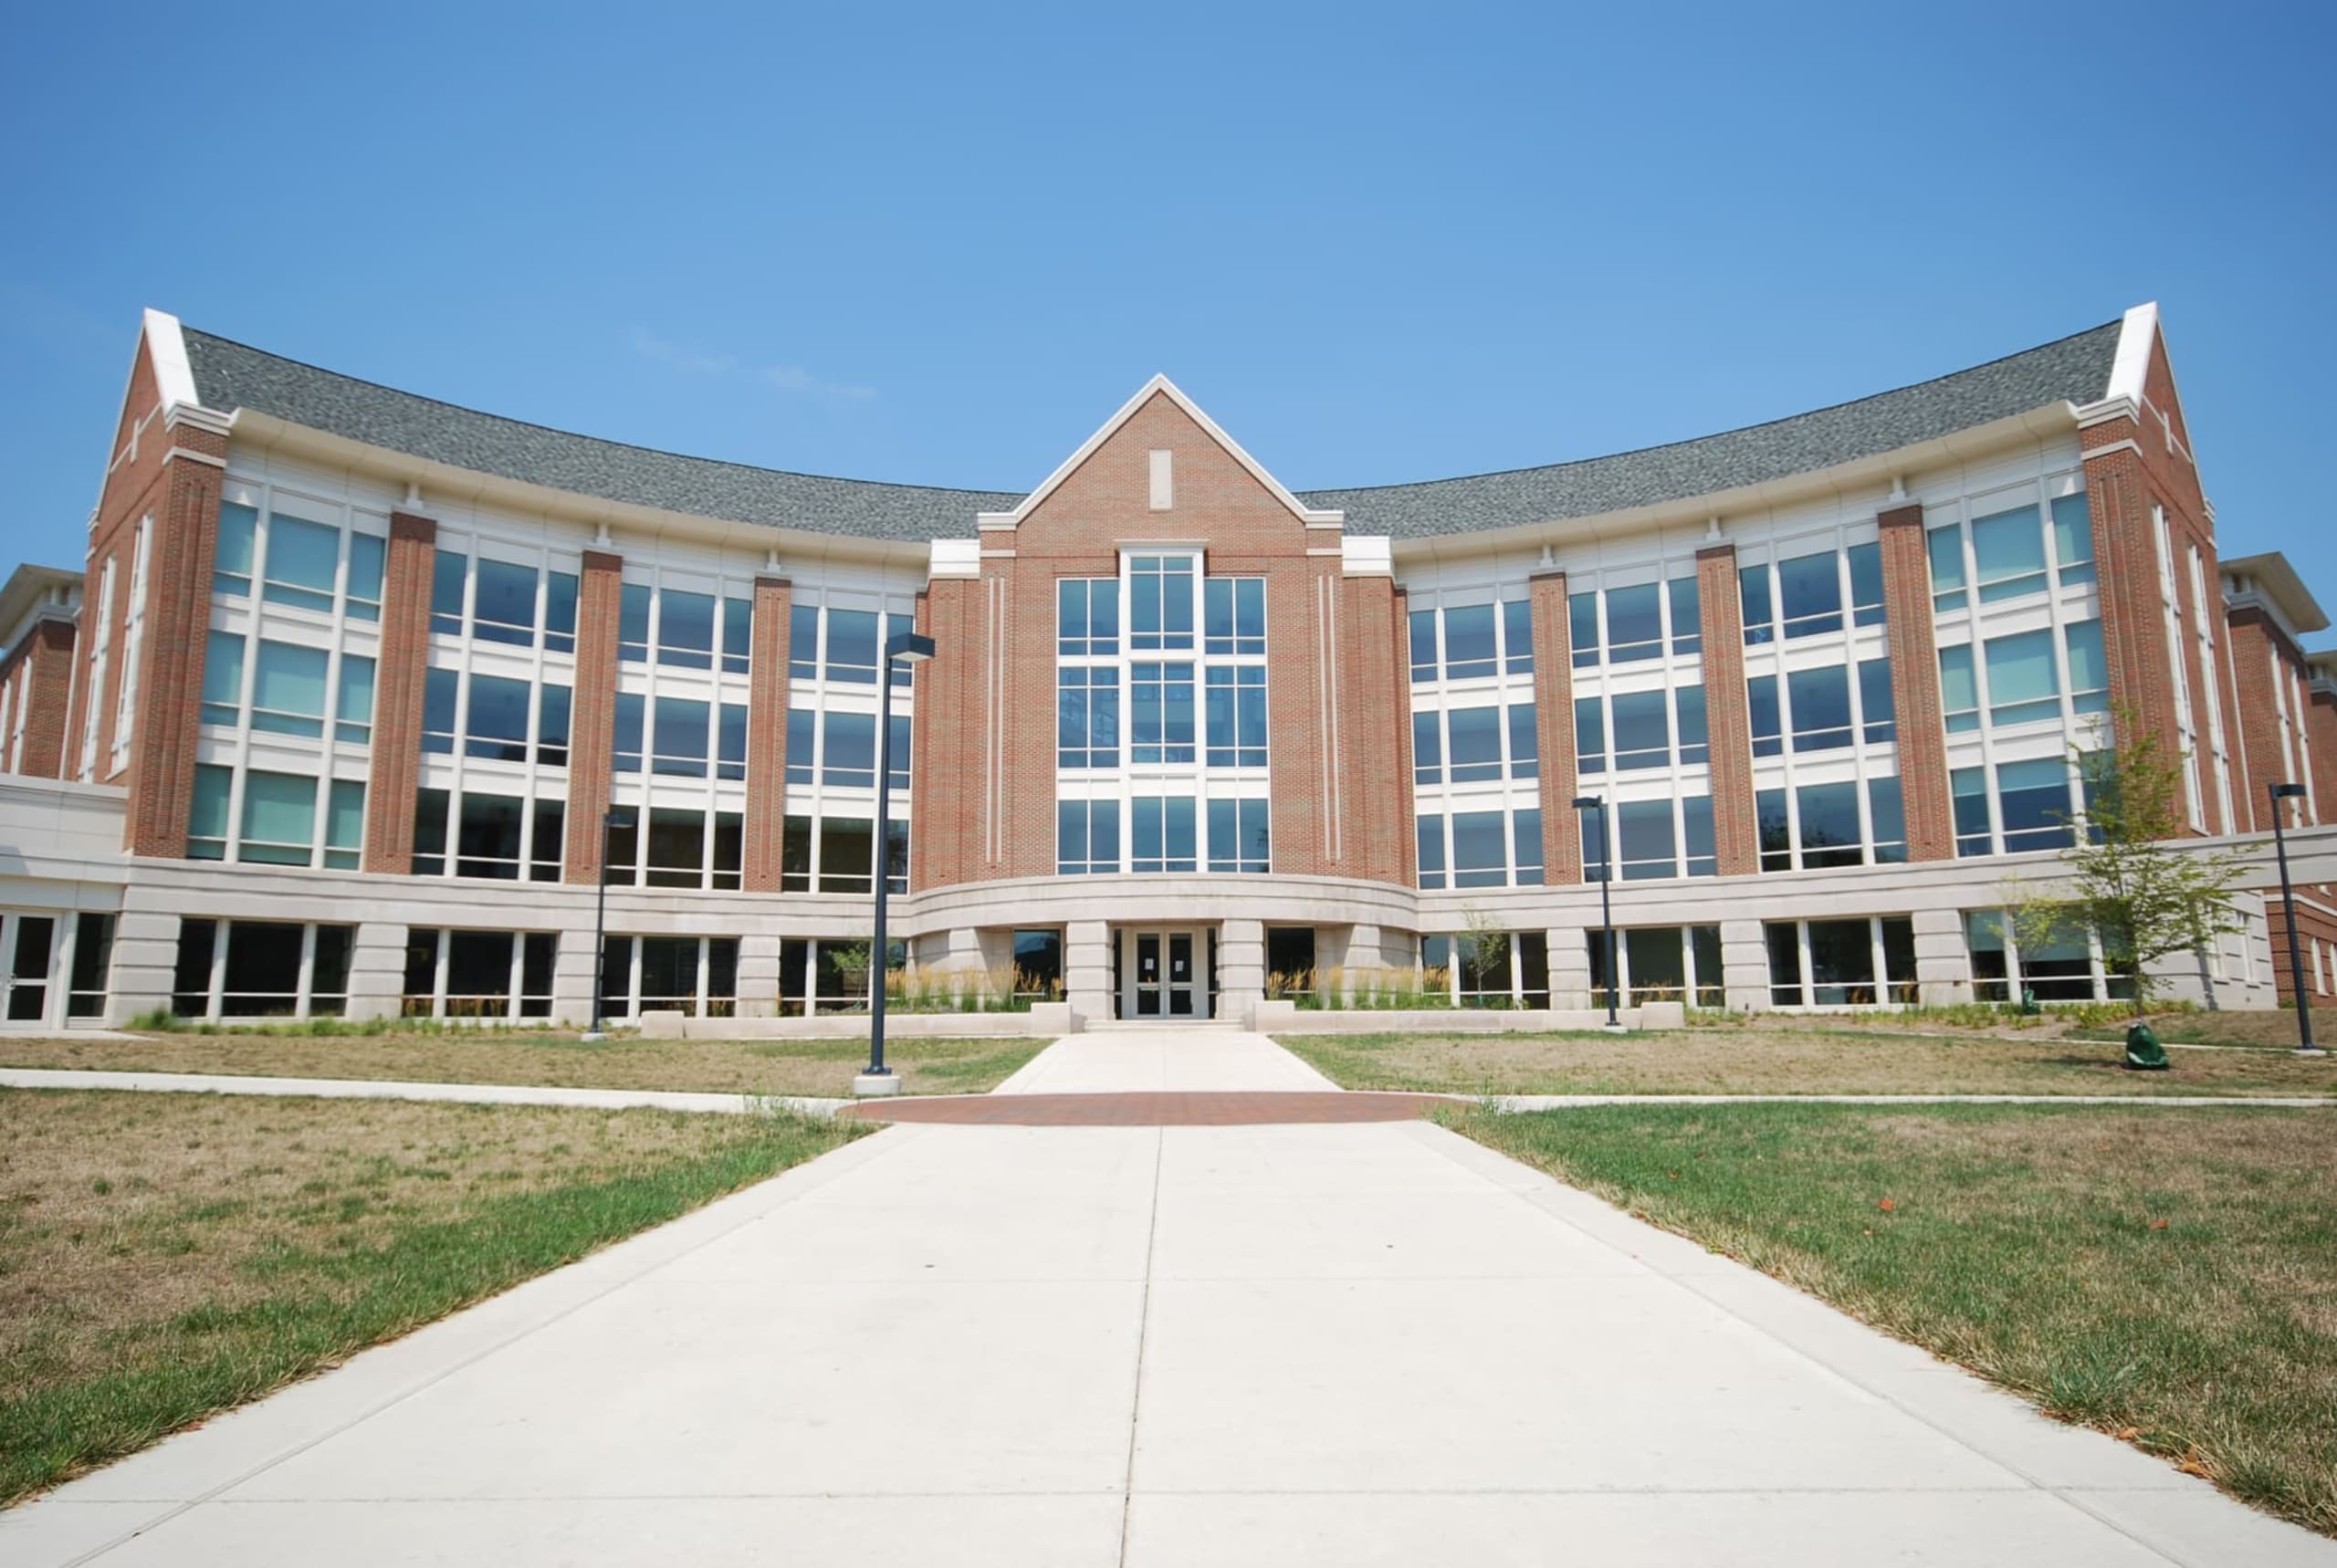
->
[1278,1026,2337,1096]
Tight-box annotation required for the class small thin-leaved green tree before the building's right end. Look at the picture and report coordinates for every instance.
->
[2007,708,2250,1017]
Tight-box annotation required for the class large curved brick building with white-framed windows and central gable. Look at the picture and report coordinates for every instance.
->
[0,306,2337,1037]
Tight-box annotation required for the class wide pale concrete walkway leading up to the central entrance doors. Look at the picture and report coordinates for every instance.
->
[0,1030,2337,1568]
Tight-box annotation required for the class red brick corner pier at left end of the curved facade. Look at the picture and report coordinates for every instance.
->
[119,425,226,860]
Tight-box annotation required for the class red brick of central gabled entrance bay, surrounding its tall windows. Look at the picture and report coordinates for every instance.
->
[917,392,1410,885]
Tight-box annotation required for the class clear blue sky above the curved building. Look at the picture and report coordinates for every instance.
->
[0,3,2337,641]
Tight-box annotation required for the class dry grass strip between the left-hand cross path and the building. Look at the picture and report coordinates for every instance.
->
[0,1030,1047,1098]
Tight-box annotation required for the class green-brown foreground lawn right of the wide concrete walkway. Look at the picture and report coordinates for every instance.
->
[1449,1105,2337,1535]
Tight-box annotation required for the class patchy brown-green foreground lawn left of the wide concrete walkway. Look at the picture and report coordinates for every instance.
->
[0,1089,865,1505]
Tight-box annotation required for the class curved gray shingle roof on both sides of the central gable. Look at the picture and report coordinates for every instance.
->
[184,320,2120,539]
